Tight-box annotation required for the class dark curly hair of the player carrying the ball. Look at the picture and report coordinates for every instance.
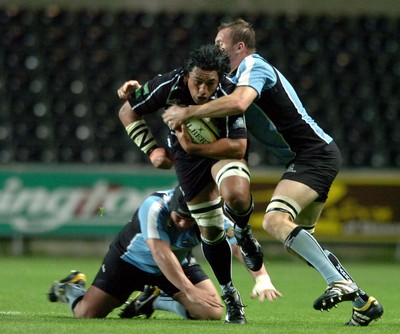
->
[184,44,230,78]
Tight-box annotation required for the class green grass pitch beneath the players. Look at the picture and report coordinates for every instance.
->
[0,255,400,334]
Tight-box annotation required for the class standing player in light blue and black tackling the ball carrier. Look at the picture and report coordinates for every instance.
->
[163,19,383,326]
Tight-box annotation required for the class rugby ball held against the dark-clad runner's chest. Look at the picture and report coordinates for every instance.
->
[185,117,219,144]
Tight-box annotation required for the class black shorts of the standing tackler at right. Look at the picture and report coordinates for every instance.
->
[281,142,342,202]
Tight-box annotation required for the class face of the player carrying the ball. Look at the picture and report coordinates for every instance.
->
[188,67,219,104]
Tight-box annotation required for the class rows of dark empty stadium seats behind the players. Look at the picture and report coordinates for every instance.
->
[0,5,400,168]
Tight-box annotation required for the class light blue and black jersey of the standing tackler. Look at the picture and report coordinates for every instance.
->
[232,54,332,163]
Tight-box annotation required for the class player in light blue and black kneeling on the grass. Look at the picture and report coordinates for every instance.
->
[49,188,281,320]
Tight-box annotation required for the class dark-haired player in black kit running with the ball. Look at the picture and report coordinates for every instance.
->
[118,45,263,323]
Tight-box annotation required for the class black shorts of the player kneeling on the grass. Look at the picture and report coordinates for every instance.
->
[92,246,208,303]
